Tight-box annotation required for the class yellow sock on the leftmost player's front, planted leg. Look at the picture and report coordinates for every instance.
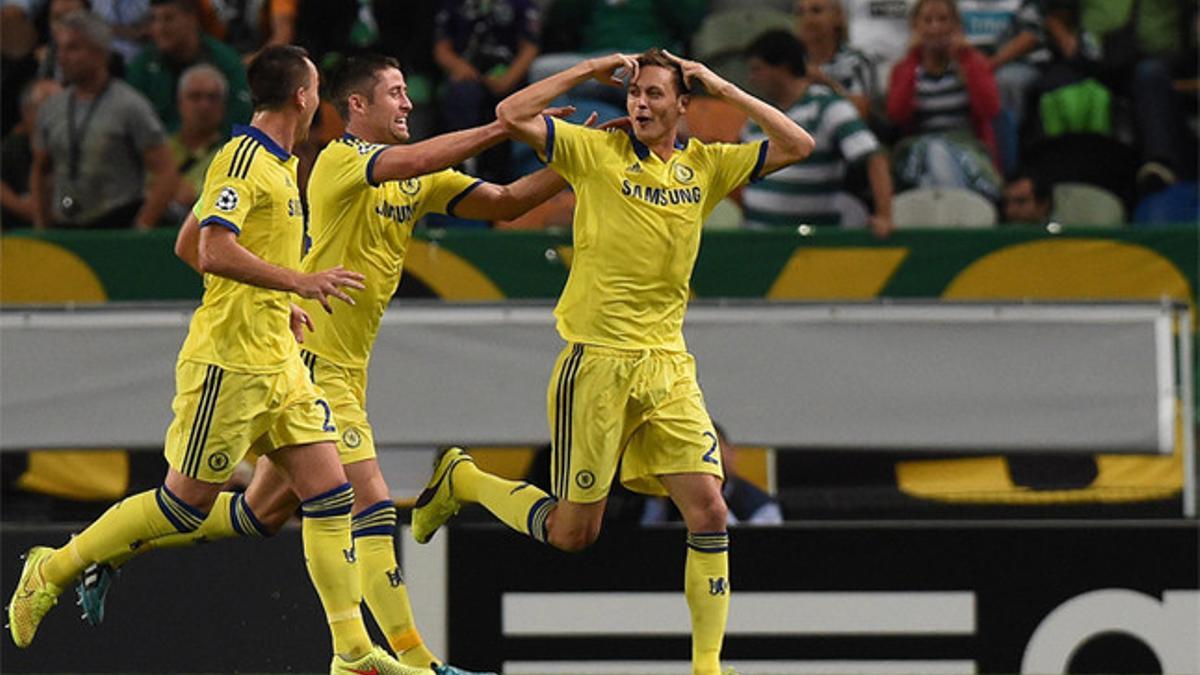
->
[300,483,371,659]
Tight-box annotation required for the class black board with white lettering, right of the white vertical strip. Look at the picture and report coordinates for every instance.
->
[448,521,1200,675]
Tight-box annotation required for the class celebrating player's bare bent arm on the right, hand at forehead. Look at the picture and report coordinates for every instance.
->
[664,52,816,174]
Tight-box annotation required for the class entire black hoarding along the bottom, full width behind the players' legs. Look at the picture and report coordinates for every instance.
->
[0,521,1200,675]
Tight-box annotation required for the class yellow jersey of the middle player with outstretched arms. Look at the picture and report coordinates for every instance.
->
[304,135,482,368]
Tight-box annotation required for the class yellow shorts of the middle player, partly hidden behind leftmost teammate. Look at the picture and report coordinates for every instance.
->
[300,350,376,464]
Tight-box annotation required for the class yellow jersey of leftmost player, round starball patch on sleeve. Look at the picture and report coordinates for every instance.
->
[179,125,305,372]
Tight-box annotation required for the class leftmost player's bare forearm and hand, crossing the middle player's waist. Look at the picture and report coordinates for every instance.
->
[199,226,366,313]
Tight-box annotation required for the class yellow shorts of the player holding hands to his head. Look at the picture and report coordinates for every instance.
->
[546,344,725,503]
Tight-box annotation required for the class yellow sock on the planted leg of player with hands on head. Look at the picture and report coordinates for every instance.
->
[684,532,730,675]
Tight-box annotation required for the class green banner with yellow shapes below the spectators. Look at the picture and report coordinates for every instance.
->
[0,225,1200,305]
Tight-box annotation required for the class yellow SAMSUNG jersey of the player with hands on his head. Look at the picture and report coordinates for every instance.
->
[544,117,767,351]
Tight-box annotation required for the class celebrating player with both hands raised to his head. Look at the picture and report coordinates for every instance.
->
[413,49,814,675]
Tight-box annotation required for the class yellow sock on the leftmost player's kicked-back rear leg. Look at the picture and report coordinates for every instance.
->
[42,485,204,587]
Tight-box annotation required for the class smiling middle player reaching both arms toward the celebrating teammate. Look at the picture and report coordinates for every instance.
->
[64,55,580,675]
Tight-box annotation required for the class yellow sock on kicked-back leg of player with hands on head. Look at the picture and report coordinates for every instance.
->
[451,461,556,543]
